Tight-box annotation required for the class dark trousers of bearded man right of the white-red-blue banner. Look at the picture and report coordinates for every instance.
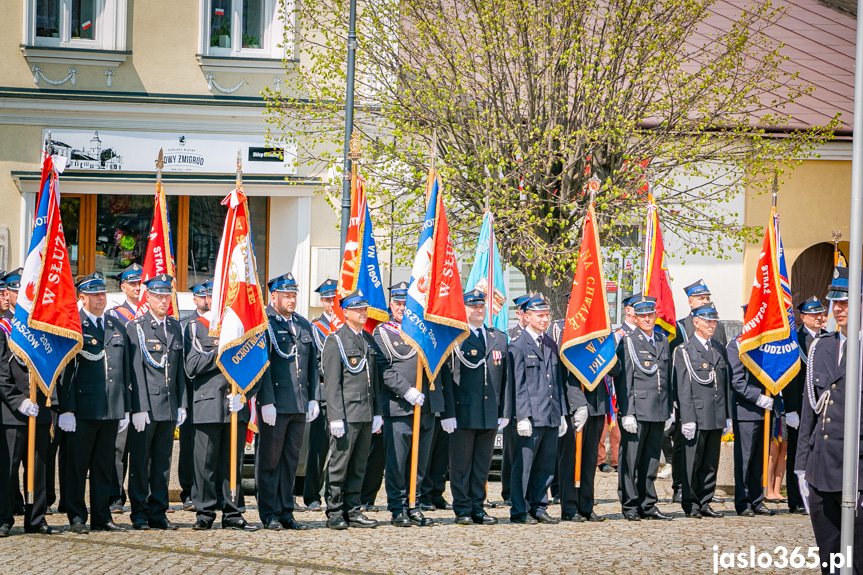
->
[255,413,306,525]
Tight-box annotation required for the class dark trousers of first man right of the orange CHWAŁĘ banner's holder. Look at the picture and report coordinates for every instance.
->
[617,421,665,515]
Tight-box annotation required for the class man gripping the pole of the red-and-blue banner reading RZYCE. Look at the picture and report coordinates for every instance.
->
[375,282,452,527]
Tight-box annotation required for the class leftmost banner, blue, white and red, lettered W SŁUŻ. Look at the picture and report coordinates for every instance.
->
[9,156,83,397]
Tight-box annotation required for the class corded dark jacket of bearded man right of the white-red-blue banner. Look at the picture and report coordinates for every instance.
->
[258,307,321,414]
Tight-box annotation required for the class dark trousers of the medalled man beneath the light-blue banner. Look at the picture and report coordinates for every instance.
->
[449,427,497,517]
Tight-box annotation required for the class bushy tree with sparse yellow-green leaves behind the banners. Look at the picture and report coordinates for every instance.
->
[266,0,838,316]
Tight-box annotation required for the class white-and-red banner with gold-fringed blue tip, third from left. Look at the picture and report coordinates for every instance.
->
[207,188,270,395]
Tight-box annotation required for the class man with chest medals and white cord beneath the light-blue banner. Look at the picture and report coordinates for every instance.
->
[442,290,509,525]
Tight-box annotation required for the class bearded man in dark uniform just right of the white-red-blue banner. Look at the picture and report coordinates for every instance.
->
[255,273,320,531]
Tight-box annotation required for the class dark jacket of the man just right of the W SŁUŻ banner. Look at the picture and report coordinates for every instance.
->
[58,310,132,420]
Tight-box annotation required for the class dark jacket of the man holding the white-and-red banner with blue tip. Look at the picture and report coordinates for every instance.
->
[184,317,253,425]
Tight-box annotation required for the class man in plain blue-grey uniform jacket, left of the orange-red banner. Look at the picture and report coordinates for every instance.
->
[504,294,568,524]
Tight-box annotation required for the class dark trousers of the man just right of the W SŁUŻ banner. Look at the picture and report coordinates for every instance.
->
[64,419,119,526]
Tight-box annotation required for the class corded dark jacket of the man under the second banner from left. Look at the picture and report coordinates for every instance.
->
[126,311,188,421]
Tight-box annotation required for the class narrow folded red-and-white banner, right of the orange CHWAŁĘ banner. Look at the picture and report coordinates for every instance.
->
[641,193,677,341]
